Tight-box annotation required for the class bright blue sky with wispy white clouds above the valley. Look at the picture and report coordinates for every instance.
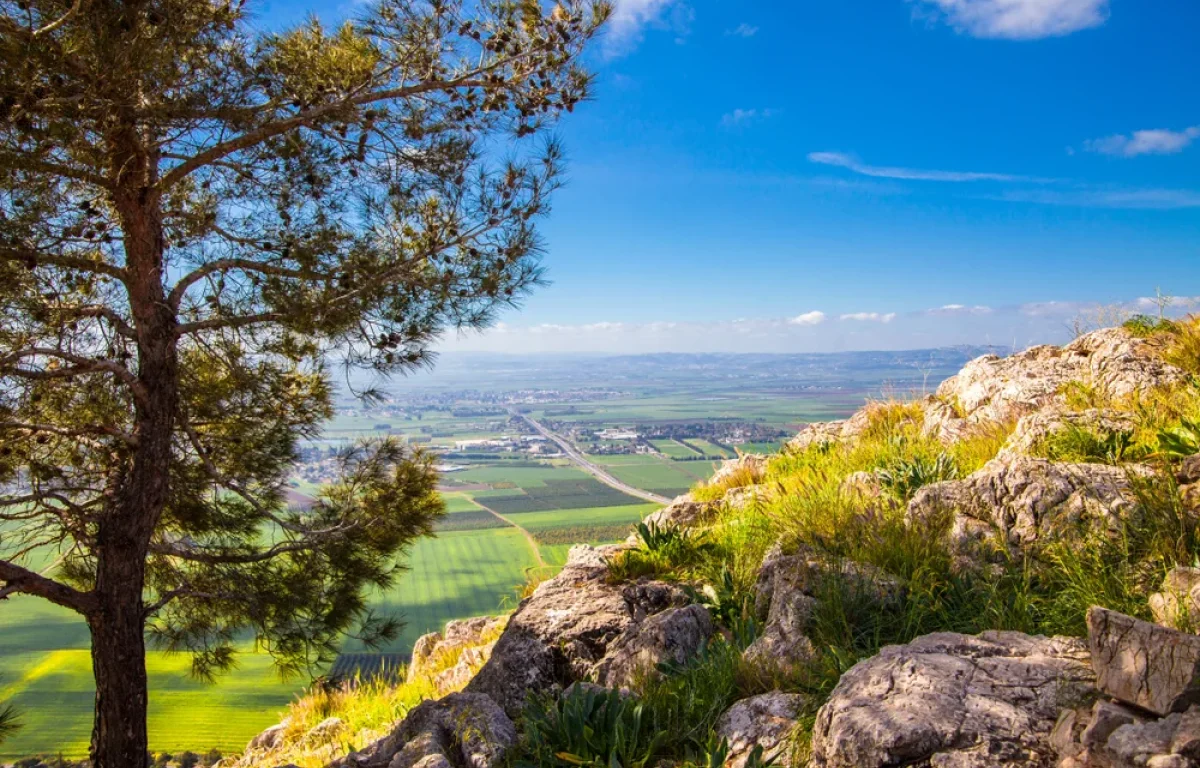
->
[259,0,1200,352]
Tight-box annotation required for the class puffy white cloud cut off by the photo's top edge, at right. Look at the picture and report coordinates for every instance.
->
[916,0,1109,40]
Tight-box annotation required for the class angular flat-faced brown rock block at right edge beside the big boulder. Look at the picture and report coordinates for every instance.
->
[1087,607,1200,715]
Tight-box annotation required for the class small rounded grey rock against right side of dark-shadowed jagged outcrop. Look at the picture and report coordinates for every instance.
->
[595,605,716,688]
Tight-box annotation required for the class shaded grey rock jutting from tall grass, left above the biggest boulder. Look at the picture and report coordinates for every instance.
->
[745,545,901,667]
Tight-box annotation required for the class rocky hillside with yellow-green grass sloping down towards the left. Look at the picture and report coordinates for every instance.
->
[229,319,1200,768]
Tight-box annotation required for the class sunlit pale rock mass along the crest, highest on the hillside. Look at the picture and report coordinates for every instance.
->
[925,328,1187,440]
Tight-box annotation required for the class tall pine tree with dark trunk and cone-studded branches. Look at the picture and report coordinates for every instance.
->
[0,0,608,768]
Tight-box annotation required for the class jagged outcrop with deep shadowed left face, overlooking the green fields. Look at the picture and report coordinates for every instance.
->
[466,546,689,716]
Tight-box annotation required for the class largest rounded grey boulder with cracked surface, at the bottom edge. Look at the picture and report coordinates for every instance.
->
[812,632,1092,768]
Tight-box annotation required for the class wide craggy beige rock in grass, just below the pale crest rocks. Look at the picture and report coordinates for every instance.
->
[907,457,1148,564]
